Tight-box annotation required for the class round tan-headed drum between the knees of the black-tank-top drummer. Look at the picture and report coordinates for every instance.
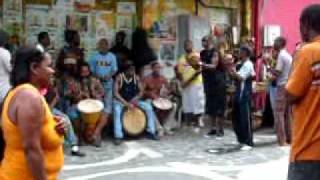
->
[122,107,147,137]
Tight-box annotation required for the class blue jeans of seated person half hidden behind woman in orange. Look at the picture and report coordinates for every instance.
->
[52,108,78,146]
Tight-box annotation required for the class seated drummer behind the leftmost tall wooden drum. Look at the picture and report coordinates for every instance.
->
[79,63,108,147]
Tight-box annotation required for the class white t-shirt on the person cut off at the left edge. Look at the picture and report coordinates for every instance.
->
[0,47,11,102]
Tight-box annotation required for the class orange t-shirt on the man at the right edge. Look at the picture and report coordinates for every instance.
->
[286,36,320,162]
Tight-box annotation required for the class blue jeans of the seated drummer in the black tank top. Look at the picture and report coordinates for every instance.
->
[113,100,157,139]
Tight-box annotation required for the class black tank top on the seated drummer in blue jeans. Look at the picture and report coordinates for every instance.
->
[120,73,139,101]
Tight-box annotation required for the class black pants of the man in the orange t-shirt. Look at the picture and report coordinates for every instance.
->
[288,161,320,180]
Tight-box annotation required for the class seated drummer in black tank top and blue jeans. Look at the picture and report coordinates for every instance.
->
[113,61,159,145]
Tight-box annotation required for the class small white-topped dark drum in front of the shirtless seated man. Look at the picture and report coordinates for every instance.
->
[152,98,173,122]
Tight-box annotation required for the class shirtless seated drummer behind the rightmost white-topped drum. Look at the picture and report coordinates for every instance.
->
[143,62,177,136]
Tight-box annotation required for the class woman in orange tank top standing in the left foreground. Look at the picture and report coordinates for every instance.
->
[0,47,64,180]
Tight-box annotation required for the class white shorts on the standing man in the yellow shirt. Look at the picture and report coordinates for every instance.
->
[182,84,205,114]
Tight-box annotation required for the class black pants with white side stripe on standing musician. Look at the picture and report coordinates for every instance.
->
[232,97,253,146]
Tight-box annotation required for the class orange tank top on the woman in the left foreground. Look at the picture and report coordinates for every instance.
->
[0,84,64,180]
